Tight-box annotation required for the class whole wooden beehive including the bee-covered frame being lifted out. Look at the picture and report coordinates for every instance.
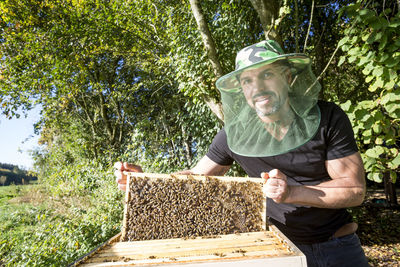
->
[74,173,306,266]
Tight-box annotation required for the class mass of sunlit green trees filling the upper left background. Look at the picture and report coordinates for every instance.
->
[0,0,230,174]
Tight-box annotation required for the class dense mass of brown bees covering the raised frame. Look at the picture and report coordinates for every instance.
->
[122,177,264,241]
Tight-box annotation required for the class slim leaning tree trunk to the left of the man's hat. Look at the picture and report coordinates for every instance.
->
[190,0,224,121]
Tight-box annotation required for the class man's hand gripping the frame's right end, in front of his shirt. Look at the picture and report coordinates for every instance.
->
[261,169,290,203]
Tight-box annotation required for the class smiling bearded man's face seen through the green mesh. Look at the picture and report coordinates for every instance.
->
[240,64,290,117]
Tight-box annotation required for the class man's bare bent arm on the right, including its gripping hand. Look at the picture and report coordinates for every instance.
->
[265,152,366,208]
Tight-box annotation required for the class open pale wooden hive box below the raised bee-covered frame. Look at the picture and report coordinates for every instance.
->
[73,226,307,267]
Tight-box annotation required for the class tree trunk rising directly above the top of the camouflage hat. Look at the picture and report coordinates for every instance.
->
[250,0,282,45]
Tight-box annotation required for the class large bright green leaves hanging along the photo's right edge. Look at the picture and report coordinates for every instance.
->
[339,1,400,182]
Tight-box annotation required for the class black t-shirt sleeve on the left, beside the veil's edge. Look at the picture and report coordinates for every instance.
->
[206,129,233,166]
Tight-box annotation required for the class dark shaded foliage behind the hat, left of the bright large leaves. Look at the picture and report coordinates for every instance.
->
[278,0,367,103]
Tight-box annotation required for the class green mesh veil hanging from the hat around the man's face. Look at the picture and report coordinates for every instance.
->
[217,50,321,157]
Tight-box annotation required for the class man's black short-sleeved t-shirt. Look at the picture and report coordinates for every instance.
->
[207,101,358,244]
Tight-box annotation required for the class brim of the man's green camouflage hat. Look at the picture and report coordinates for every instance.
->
[216,53,311,91]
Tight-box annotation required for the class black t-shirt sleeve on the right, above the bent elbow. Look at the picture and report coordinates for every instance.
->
[327,104,358,160]
